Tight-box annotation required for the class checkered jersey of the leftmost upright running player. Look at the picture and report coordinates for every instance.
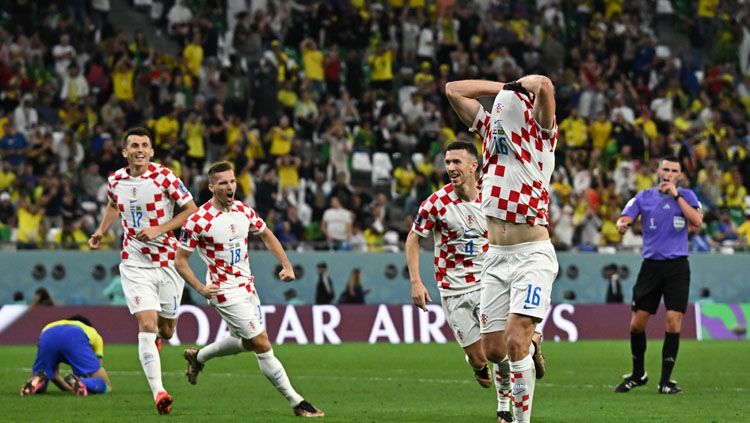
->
[107,163,193,267]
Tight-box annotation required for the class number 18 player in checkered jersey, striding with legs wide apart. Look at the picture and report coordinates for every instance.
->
[175,162,324,417]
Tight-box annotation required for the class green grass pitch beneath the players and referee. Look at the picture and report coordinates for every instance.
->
[0,341,750,423]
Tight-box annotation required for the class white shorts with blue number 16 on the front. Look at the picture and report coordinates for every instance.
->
[480,241,558,333]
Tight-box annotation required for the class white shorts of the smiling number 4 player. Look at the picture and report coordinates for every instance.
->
[440,289,481,348]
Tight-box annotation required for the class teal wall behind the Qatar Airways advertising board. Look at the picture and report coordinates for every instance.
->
[0,251,750,305]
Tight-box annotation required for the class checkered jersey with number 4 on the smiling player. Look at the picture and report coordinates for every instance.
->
[411,184,489,296]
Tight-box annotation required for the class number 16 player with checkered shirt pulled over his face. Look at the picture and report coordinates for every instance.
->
[445,75,558,422]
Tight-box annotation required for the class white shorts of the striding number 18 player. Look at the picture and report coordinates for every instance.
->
[209,284,266,339]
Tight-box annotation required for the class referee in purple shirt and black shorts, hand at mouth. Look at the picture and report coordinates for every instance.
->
[615,156,703,394]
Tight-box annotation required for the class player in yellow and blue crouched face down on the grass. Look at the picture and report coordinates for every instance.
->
[21,314,112,397]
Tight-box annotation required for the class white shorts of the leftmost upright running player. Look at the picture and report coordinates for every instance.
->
[120,264,185,319]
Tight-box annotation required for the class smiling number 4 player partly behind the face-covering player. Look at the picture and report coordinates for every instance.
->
[406,141,512,419]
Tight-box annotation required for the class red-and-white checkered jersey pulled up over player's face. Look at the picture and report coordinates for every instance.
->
[470,90,557,226]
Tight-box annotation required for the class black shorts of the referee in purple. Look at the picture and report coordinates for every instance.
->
[632,257,690,314]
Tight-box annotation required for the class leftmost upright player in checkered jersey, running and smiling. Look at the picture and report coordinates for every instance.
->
[89,128,197,414]
